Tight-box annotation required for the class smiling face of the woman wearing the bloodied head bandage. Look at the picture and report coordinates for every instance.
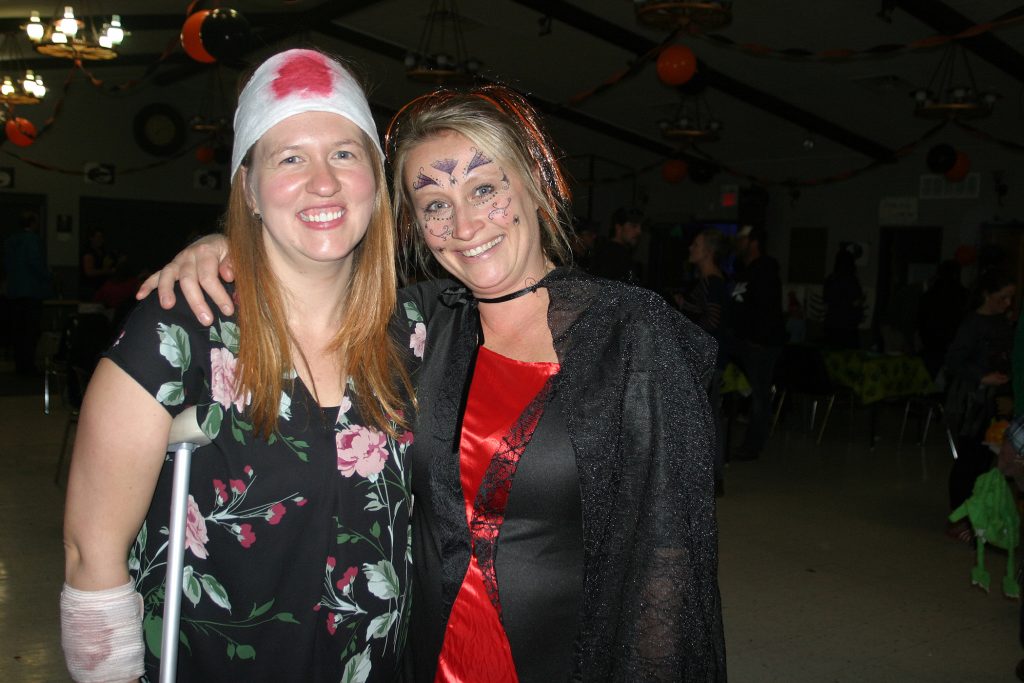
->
[243,112,377,272]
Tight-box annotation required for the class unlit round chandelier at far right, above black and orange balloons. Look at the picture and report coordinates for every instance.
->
[910,43,999,119]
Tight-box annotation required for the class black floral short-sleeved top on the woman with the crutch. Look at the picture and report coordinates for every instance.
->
[108,296,422,682]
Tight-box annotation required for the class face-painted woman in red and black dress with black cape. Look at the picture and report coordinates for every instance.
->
[144,86,725,683]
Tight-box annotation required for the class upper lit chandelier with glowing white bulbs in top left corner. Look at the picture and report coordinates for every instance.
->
[25,5,127,61]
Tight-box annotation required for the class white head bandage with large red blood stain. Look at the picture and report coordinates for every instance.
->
[231,50,384,179]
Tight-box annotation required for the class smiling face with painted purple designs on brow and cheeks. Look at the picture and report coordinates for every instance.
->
[402,131,549,298]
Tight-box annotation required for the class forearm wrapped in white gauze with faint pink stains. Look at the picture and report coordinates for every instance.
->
[60,582,145,683]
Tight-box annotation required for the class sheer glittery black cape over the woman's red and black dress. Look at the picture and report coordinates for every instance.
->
[400,269,726,683]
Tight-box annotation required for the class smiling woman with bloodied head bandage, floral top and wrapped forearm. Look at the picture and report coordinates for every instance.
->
[60,50,412,682]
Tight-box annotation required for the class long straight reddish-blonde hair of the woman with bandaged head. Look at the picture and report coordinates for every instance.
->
[224,127,413,438]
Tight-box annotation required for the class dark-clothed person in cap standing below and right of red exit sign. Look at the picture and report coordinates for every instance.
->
[728,225,785,460]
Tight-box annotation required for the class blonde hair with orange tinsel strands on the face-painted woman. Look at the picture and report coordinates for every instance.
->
[384,85,572,271]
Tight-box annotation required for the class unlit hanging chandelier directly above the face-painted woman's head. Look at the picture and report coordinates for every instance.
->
[406,0,480,85]
